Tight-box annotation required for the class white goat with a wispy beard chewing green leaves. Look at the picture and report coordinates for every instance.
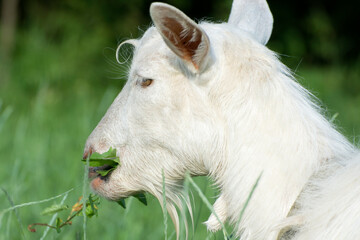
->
[85,0,360,240]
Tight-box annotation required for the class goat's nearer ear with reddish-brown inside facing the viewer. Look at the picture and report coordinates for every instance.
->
[150,3,210,72]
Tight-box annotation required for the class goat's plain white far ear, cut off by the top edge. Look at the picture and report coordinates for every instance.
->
[228,0,274,45]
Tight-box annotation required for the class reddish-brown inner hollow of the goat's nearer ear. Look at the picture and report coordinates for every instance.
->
[162,17,202,69]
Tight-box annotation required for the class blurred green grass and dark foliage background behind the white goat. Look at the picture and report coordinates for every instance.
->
[0,0,360,239]
